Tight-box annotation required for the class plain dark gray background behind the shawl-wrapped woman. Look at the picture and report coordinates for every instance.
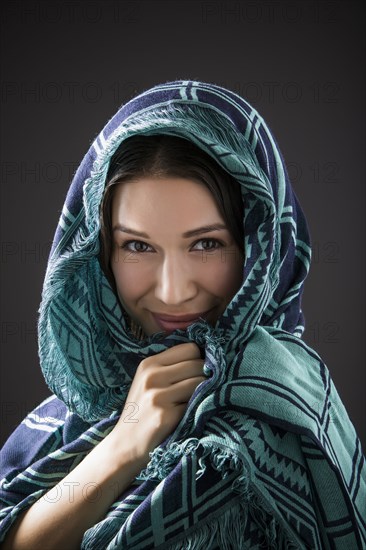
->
[1,0,365,448]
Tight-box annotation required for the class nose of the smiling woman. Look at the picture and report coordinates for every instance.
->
[155,254,198,305]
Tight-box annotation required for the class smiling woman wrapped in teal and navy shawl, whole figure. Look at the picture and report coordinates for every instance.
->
[1,81,366,549]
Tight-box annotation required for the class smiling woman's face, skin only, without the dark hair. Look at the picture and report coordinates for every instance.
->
[111,177,243,335]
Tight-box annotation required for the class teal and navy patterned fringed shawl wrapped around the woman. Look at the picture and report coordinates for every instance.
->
[0,81,366,550]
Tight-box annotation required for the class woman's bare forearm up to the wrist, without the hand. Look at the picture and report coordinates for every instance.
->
[2,437,144,550]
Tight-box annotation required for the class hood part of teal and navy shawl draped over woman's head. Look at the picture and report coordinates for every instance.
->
[39,81,310,421]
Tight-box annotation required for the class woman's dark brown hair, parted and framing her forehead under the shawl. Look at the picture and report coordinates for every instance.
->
[100,134,244,288]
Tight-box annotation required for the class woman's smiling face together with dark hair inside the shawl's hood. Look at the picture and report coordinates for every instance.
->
[101,136,243,337]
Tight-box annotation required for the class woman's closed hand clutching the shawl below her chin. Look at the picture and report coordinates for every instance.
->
[107,342,205,464]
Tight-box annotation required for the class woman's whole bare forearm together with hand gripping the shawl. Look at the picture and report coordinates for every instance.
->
[2,343,204,550]
